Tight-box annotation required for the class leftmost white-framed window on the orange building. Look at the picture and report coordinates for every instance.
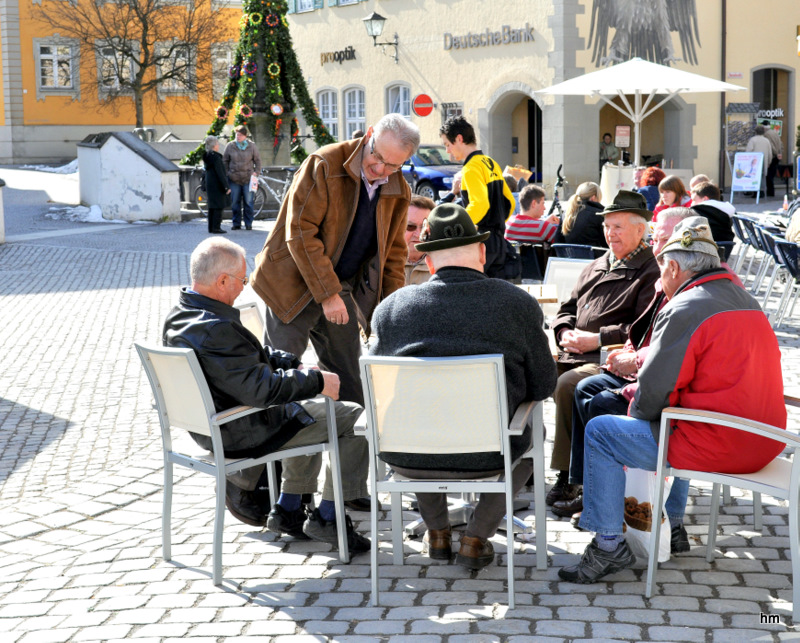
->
[33,36,81,100]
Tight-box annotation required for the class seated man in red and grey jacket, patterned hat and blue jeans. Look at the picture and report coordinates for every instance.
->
[558,217,786,583]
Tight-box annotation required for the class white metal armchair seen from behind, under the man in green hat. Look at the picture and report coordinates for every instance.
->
[360,355,547,608]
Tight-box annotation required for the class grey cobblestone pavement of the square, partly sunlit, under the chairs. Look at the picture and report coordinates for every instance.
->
[0,172,800,643]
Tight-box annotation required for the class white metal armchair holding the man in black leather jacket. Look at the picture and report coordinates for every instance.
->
[134,343,350,585]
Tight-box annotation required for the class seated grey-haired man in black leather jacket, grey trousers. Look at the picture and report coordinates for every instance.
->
[163,238,370,553]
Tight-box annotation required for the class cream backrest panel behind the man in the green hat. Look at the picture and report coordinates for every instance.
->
[360,355,509,454]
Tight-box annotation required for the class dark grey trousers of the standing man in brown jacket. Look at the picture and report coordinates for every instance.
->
[265,284,364,406]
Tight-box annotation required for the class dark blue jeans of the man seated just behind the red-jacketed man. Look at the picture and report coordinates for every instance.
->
[569,372,630,484]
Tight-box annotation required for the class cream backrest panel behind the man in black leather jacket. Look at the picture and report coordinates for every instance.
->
[134,343,216,437]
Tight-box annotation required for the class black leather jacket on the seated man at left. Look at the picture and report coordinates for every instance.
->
[162,288,324,457]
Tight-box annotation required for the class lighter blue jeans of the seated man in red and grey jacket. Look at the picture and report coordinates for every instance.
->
[580,415,689,536]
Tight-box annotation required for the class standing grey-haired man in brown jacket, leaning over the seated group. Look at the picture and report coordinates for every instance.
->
[251,114,419,404]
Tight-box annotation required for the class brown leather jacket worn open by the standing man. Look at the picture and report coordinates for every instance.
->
[251,138,411,323]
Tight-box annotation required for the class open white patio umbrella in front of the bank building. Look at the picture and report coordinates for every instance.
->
[536,58,745,164]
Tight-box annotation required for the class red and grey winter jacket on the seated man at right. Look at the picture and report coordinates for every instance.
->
[630,269,786,473]
